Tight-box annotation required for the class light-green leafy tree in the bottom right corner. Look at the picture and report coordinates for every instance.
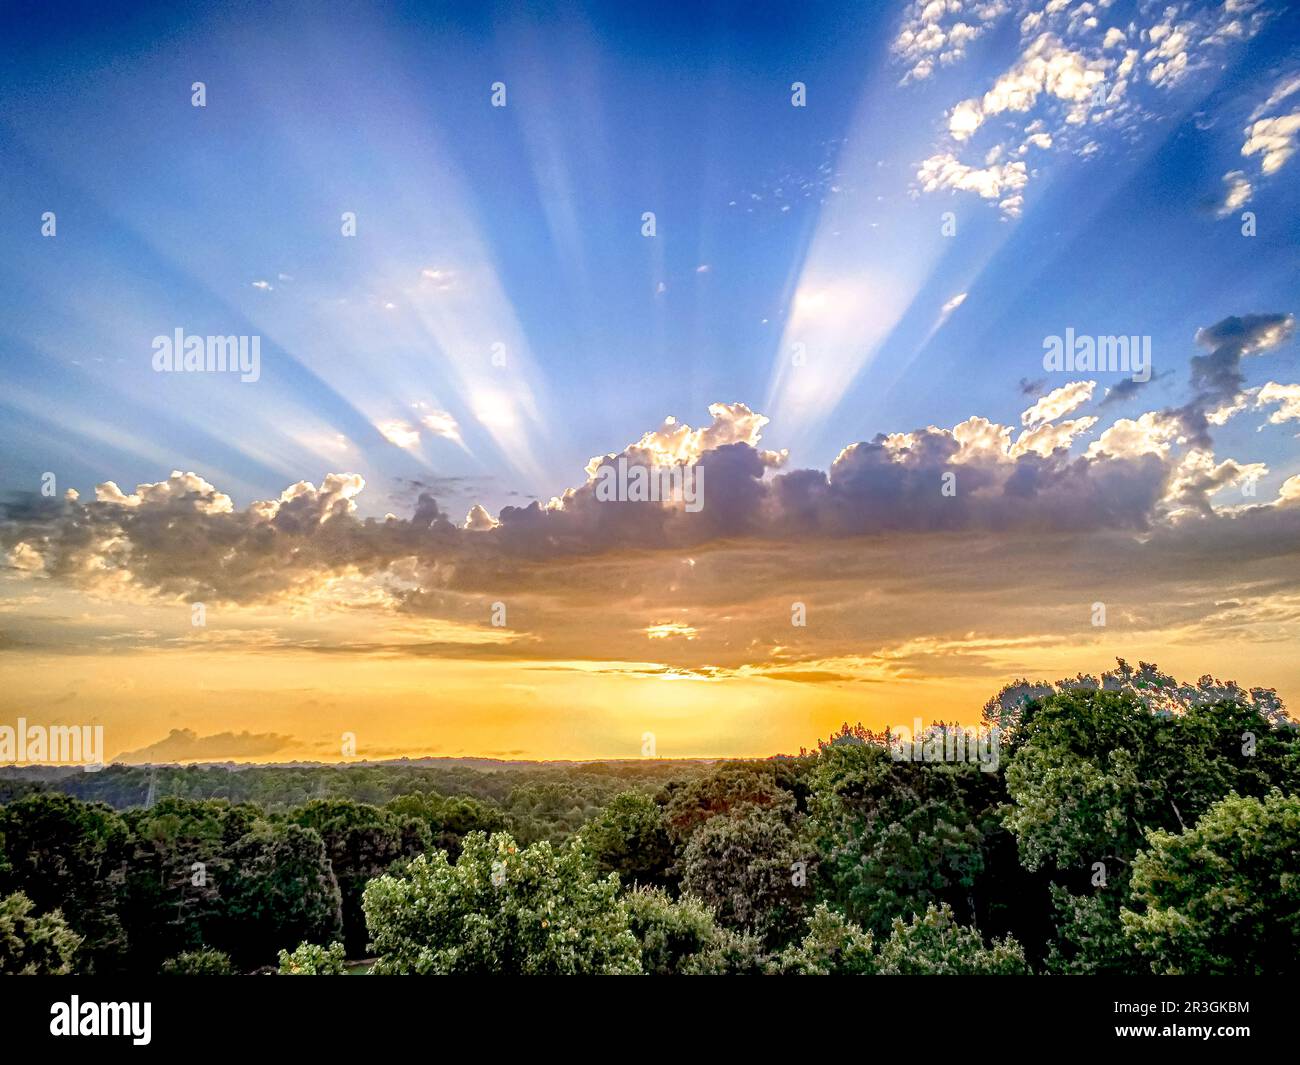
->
[1121,791,1300,975]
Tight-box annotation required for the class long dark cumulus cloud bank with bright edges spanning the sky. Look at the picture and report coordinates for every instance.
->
[0,313,1296,624]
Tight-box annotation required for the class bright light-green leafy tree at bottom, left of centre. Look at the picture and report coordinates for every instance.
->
[363,832,641,975]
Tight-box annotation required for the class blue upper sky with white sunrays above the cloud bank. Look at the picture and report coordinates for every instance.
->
[0,3,1300,517]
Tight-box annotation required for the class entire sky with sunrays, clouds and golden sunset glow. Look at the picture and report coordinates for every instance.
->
[0,0,1300,761]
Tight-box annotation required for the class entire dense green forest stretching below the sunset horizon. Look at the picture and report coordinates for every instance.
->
[0,659,1300,975]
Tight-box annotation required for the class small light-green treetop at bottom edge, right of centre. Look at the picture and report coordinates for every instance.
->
[878,904,1030,977]
